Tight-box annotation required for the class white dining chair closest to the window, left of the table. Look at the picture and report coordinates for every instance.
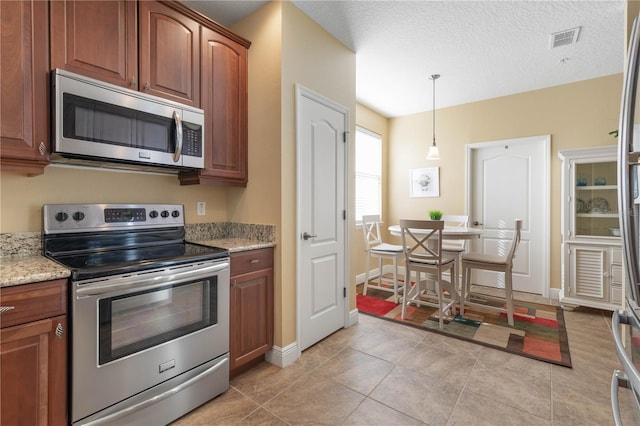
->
[362,215,403,302]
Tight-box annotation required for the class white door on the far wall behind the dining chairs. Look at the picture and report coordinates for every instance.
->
[467,135,551,296]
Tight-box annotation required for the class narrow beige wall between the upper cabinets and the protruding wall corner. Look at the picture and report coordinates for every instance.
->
[229,2,282,346]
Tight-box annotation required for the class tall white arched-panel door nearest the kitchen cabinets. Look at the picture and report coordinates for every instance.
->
[296,86,349,351]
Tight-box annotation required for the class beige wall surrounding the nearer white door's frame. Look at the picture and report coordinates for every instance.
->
[282,2,356,336]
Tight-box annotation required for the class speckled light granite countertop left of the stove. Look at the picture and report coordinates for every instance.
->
[0,254,71,288]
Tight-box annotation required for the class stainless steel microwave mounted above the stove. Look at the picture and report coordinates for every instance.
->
[51,69,204,170]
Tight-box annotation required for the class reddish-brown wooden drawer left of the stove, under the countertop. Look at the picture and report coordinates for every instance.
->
[0,279,67,328]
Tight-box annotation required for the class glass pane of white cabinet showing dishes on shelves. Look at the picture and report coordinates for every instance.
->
[574,161,620,237]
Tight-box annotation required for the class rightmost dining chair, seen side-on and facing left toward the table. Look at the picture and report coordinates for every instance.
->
[460,219,522,327]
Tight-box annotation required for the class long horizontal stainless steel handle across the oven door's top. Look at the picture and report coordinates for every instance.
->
[75,262,229,296]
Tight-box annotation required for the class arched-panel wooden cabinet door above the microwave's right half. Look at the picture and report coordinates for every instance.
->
[139,1,199,107]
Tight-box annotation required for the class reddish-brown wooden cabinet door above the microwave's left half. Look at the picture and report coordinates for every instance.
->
[51,0,138,89]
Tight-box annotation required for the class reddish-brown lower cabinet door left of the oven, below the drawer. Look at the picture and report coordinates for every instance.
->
[0,315,67,426]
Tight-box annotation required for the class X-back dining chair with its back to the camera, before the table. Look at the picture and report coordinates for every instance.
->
[400,220,457,329]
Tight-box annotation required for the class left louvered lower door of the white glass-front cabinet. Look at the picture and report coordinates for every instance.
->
[571,246,609,301]
